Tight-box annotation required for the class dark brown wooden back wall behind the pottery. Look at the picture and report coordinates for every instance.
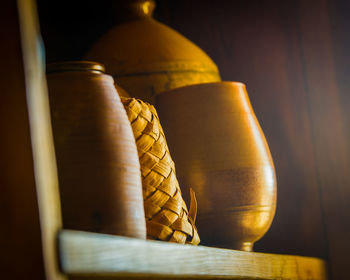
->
[38,0,350,280]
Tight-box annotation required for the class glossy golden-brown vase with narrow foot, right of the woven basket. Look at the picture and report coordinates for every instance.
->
[157,82,276,251]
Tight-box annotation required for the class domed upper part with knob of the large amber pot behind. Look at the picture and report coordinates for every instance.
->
[87,0,218,76]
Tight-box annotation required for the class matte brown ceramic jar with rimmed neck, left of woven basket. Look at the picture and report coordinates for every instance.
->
[47,62,146,238]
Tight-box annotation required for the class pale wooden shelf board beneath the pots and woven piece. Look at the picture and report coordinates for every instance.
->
[59,230,327,280]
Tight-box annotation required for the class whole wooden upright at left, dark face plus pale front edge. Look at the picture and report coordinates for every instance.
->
[0,1,62,279]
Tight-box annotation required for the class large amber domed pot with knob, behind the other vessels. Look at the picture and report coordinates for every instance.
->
[86,0,220,103]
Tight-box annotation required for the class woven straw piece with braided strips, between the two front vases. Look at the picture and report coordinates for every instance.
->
[121,98,200,245]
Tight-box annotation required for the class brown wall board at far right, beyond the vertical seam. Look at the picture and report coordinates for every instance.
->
[299,0,350,280]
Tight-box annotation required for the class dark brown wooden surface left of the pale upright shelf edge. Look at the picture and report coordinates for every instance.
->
[0,0,45,280]
